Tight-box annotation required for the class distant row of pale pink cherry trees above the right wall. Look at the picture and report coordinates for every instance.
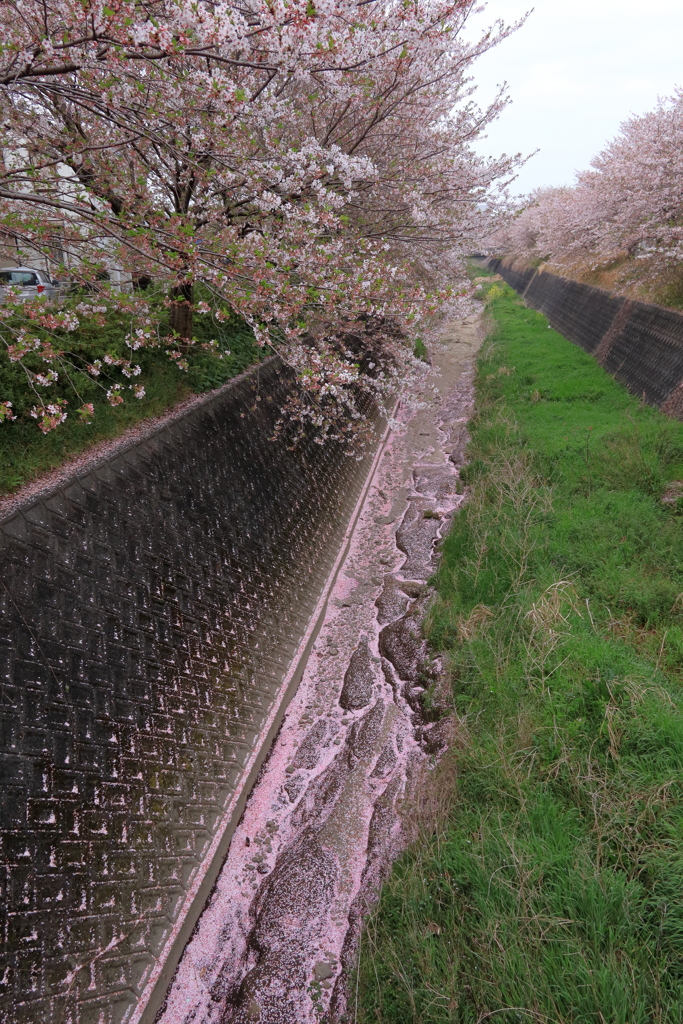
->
[494,89,683,299]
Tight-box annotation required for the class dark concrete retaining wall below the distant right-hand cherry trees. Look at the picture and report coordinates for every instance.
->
[488,259,683,419]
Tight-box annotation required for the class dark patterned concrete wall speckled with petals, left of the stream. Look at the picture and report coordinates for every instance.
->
[0,359,382,1024]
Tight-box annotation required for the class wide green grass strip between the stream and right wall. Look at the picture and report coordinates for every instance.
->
[358,286,683,1024]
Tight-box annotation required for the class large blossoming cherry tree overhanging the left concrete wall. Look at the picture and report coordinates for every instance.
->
[0,0,515,436]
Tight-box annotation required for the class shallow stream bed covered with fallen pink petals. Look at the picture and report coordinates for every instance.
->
[157,322,481,1024]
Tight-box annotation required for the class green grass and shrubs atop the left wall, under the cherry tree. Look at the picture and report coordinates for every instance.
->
[0,293,268,494]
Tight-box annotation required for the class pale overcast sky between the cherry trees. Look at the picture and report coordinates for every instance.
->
[470,0,683,193]
